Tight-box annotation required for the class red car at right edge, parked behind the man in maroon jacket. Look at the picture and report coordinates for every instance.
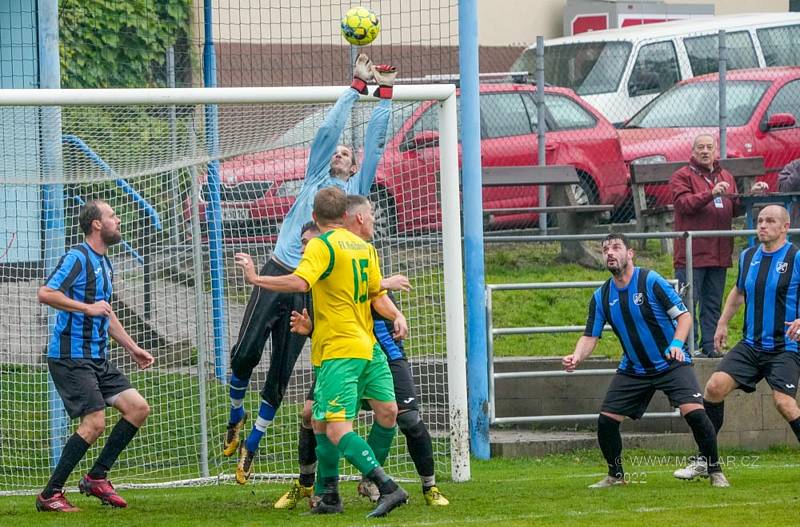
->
[619,67,800,204]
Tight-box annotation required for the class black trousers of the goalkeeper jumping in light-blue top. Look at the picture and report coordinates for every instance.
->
[231,259,310,409]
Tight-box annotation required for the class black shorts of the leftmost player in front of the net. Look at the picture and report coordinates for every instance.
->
[47,359,132,419]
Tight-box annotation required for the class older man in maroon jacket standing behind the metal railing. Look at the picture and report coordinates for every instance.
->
[670,134,767,357]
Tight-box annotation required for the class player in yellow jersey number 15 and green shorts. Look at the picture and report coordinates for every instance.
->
[231,187,408,517]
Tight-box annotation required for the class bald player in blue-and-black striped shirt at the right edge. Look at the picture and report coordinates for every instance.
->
[674,205,800,479]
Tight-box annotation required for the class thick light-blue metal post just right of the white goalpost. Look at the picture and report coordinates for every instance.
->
[458,0,490,459]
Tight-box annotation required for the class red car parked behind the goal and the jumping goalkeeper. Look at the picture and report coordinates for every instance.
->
[192,84,627,242]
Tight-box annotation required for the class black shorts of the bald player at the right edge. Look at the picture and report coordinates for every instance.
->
[716,342,800,397]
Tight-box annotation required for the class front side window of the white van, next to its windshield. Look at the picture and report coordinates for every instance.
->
[628,41,680,97]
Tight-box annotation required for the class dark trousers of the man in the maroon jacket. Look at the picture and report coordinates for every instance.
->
[675,267,728,355]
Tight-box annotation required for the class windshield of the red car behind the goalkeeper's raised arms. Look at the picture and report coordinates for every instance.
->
[274,102,420,151]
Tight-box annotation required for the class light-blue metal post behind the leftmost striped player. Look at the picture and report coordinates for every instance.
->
[37,0,68,468]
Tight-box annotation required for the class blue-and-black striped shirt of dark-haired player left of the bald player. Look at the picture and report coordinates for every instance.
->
[583,267,691,376]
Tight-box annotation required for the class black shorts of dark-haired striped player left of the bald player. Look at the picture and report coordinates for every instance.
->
[601,364,703,419]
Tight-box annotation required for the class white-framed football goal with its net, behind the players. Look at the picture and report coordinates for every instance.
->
[0,86,469,493]
